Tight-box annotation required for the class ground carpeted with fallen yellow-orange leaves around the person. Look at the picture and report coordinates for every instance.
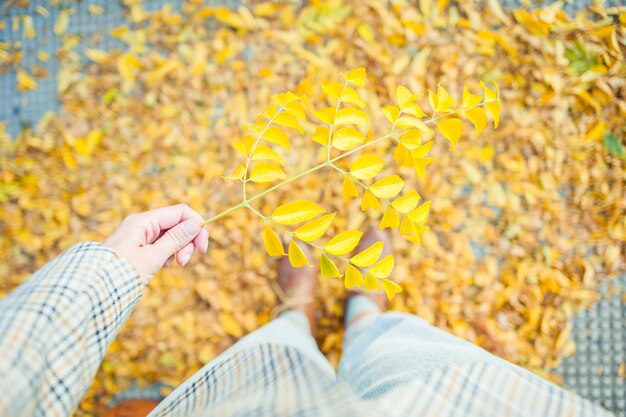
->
[0,0,626,415]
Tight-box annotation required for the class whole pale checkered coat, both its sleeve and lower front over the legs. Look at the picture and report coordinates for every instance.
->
[0,242,609,417]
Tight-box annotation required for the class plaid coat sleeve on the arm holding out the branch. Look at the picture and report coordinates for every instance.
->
[0,242,144,417]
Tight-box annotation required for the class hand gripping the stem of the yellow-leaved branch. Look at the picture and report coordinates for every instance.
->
[104,204,209,283]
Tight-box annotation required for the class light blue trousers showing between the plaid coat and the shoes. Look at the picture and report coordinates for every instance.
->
[212,296,515,399]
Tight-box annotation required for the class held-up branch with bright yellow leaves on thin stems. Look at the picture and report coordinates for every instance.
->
[203,68,500,299]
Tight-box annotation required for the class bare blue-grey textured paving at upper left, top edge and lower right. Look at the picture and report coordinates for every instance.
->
[0,0,626,417]
